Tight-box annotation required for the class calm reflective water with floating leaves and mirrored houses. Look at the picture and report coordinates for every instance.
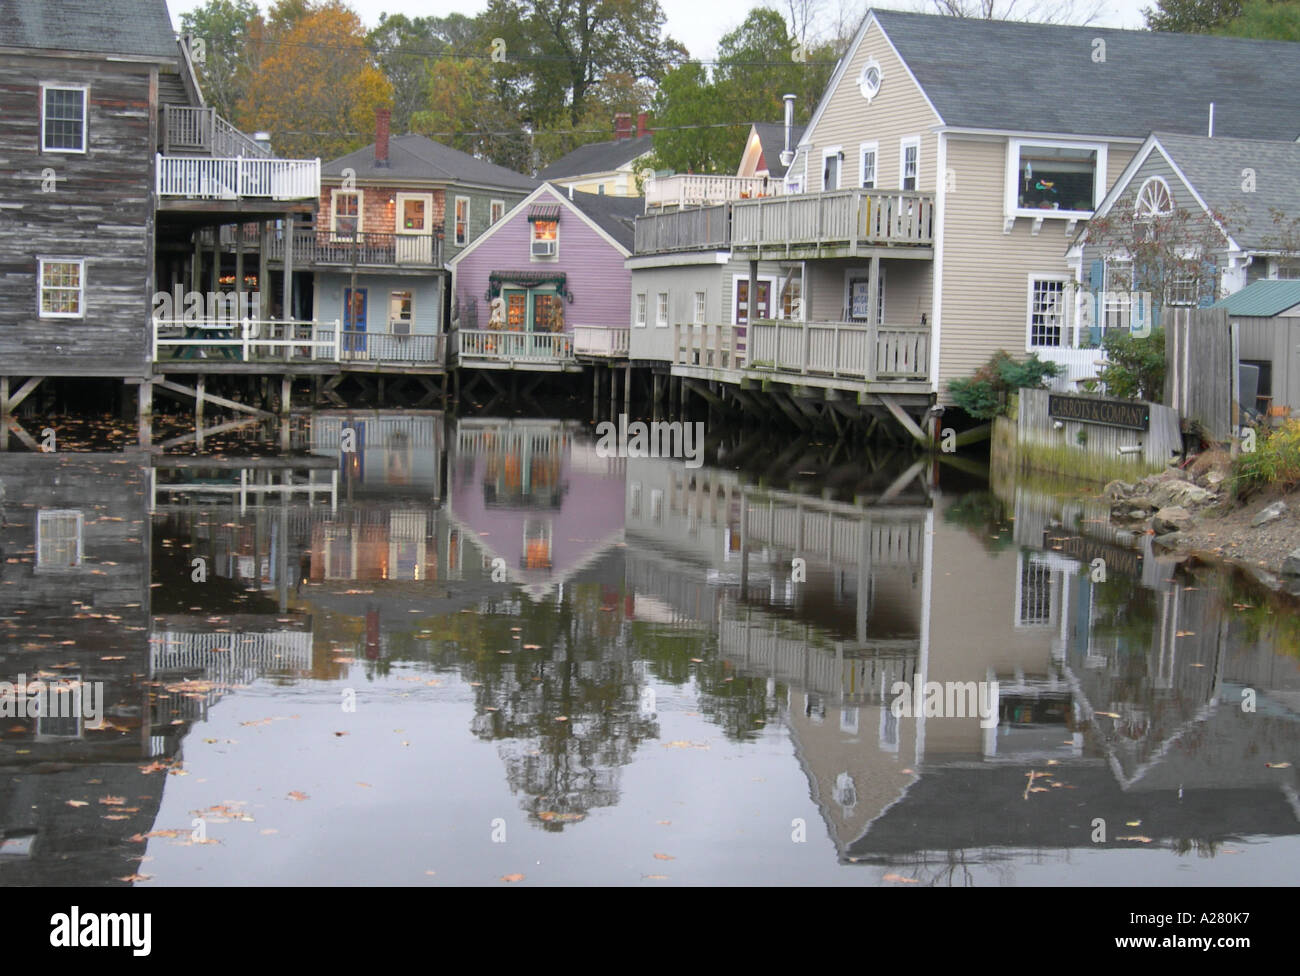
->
[0,412,1300,886]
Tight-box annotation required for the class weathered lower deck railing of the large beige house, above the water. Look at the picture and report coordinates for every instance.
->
[748,320,930,382]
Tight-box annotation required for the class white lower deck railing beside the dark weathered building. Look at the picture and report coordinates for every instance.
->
[150,318,342,363]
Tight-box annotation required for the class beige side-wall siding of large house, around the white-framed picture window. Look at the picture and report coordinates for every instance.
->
[939,138,1135,403]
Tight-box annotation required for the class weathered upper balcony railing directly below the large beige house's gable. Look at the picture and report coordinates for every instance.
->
[732,190,935,248]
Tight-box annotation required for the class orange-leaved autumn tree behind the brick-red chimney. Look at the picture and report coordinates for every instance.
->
[238,0,393,159]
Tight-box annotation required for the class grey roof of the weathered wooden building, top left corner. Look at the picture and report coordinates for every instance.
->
[0,0,179,61]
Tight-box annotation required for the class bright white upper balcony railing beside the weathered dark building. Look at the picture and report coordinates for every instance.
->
[155,153,321,200]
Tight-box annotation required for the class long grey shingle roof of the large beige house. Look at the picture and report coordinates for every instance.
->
[814,9,1300,139]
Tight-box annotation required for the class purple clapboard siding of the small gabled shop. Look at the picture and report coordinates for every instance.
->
[452,195,632,333]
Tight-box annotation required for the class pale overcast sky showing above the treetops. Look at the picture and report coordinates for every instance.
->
[168,0,1154,58]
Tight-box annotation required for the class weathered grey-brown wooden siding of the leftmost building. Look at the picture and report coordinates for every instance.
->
[0,55,157,376]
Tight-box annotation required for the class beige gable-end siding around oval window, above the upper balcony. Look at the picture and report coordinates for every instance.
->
[796,25,940,192]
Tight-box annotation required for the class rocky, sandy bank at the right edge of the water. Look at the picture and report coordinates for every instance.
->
[1102,454,1300,595]
